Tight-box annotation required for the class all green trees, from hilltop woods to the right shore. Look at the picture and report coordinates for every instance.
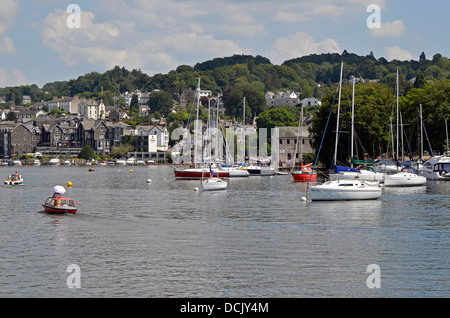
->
[0,51,450,164]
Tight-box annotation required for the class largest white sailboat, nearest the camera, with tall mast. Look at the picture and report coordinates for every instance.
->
[309,62,382,201]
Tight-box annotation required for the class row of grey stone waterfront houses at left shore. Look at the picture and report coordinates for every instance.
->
[0,115,169,158]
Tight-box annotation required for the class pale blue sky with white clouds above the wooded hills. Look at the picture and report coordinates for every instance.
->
[0,0,450,87]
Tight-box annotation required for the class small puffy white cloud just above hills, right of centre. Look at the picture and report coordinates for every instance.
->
[269,32,340,64]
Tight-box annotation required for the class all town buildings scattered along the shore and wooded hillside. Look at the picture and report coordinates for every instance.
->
[0,90,321,167]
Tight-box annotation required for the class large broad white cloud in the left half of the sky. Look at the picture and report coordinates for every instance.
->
[41,0,251,74]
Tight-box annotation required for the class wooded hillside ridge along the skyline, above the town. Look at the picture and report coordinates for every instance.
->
[0,51,450,105]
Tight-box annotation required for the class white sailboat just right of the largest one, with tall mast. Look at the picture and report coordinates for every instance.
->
[384,70,427,187]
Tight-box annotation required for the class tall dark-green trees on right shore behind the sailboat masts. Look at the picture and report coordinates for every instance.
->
[310,79,450,167]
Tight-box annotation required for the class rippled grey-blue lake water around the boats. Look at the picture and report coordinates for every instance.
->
[0,166,450,298]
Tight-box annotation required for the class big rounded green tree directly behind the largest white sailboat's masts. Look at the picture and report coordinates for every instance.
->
[310,83,394,167]
